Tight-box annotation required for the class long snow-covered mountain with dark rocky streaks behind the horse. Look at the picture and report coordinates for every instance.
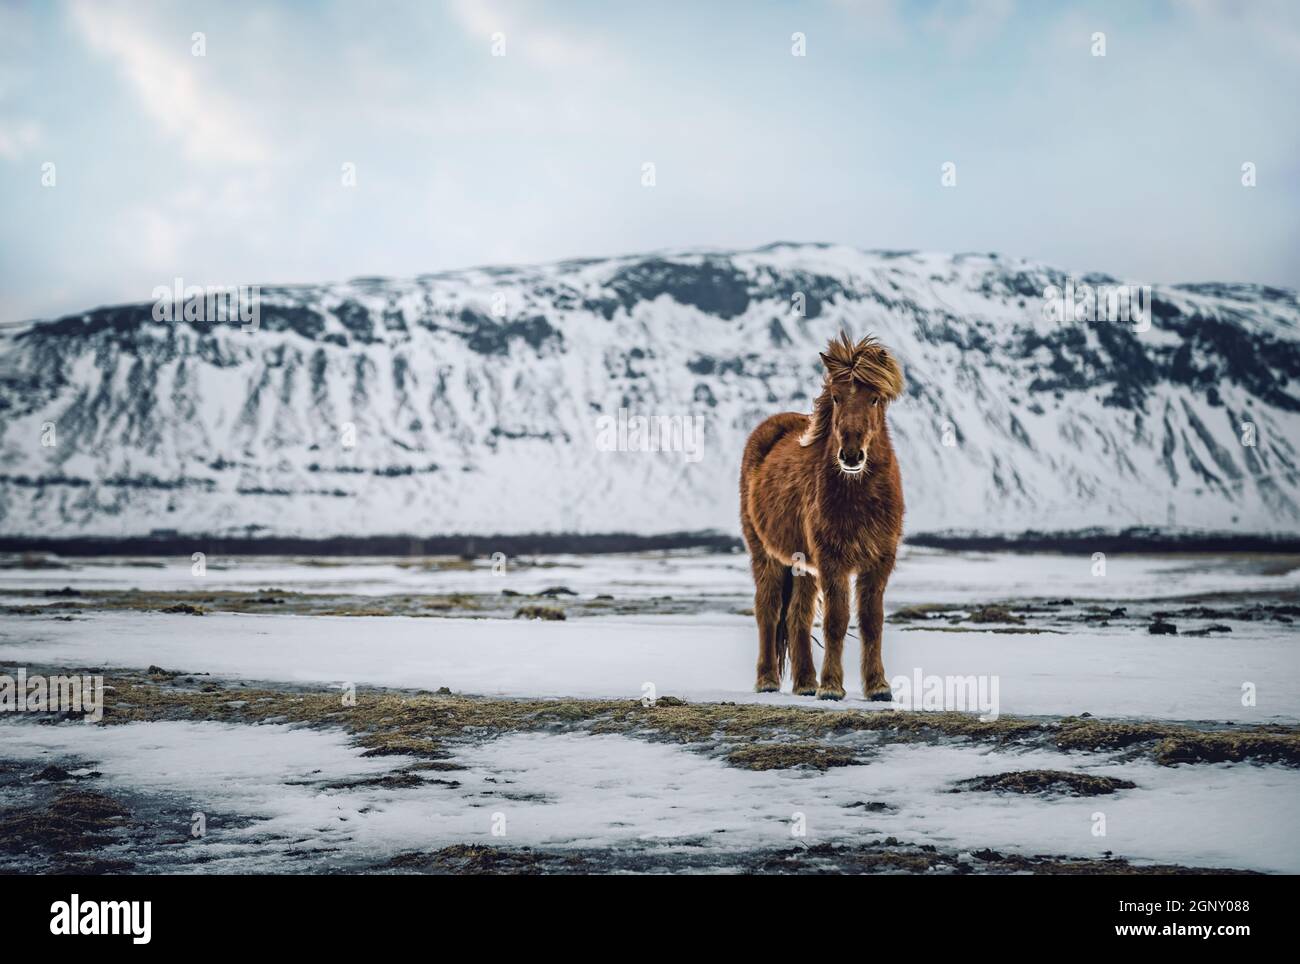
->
[0,244,1300,537]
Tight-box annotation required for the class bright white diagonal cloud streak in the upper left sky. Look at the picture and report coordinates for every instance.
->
[69,0,268,164]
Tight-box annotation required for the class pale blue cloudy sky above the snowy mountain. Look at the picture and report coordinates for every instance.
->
[0,0,1300,321]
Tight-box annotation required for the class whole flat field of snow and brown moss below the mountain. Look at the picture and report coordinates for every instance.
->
[0,551,1300,873]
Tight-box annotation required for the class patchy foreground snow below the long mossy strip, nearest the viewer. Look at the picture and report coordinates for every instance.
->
[0,722,1300,873]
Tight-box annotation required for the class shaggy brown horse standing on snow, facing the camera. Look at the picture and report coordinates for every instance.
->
[740,333,902,700]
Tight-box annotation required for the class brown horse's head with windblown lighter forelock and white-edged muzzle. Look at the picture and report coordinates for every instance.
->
[802,333,902,476]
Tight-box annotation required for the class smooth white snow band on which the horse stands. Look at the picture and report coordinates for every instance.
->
[0,613,1300,722]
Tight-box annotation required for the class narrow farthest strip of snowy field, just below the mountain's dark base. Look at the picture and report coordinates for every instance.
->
[0,546,1300,607]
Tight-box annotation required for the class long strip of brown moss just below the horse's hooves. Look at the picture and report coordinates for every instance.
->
[83,668,1300,767]
